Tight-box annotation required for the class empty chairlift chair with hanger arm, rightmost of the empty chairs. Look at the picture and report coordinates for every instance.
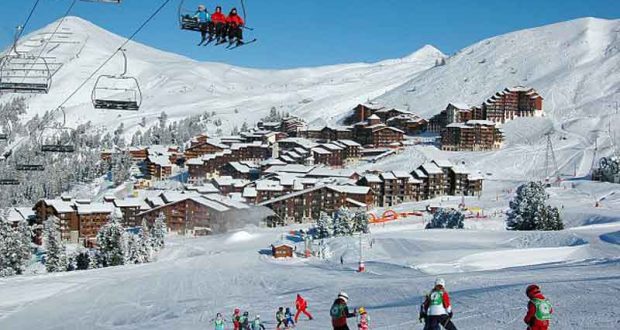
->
[91,49,142,111]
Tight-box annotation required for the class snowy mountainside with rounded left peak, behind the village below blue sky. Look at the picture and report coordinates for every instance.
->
[0,17,444,132]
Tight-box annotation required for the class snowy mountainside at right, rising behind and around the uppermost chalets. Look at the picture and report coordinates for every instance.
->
[368,18,620,180]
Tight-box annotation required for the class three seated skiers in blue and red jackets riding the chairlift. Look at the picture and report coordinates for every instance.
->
[192,5,245,46]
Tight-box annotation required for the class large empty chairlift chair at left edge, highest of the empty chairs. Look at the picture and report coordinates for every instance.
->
[0,47,52,94]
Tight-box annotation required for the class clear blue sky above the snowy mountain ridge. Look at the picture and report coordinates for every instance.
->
[0,0,620,68]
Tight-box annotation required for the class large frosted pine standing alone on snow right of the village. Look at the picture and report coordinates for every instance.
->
[506,182,564,230]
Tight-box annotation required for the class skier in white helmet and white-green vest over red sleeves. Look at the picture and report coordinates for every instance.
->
[424,278,456,330]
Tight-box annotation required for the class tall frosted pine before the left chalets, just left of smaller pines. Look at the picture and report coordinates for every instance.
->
[97,216,126,267]
